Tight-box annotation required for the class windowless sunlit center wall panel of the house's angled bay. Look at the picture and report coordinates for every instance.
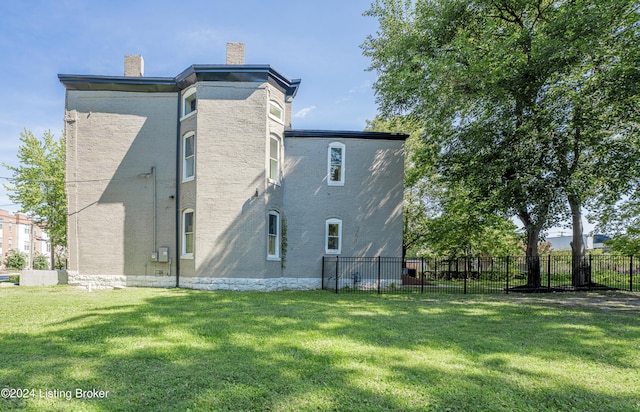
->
[189,82,267,283]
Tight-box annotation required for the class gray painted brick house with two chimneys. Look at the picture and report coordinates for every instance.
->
[58,43,407,290]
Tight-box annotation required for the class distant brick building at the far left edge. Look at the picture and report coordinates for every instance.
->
[0,210,51,269]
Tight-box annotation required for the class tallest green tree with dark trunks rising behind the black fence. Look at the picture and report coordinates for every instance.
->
[363,0,637,287]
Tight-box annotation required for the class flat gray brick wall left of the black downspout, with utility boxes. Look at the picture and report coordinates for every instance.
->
[65,90,178,284]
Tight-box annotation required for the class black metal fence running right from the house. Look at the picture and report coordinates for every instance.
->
[322,255,640,294]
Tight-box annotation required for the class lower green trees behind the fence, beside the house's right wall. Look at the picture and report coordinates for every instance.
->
[367,117,519,257]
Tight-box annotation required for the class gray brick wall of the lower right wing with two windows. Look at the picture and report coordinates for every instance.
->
[285,137,404,278]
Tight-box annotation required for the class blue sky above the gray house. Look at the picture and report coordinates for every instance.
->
[0,0,377,211]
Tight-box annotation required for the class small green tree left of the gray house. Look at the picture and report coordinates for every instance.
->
[4,129,67,264]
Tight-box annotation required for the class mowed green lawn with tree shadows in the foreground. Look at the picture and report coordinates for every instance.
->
[0,287,640,411]
